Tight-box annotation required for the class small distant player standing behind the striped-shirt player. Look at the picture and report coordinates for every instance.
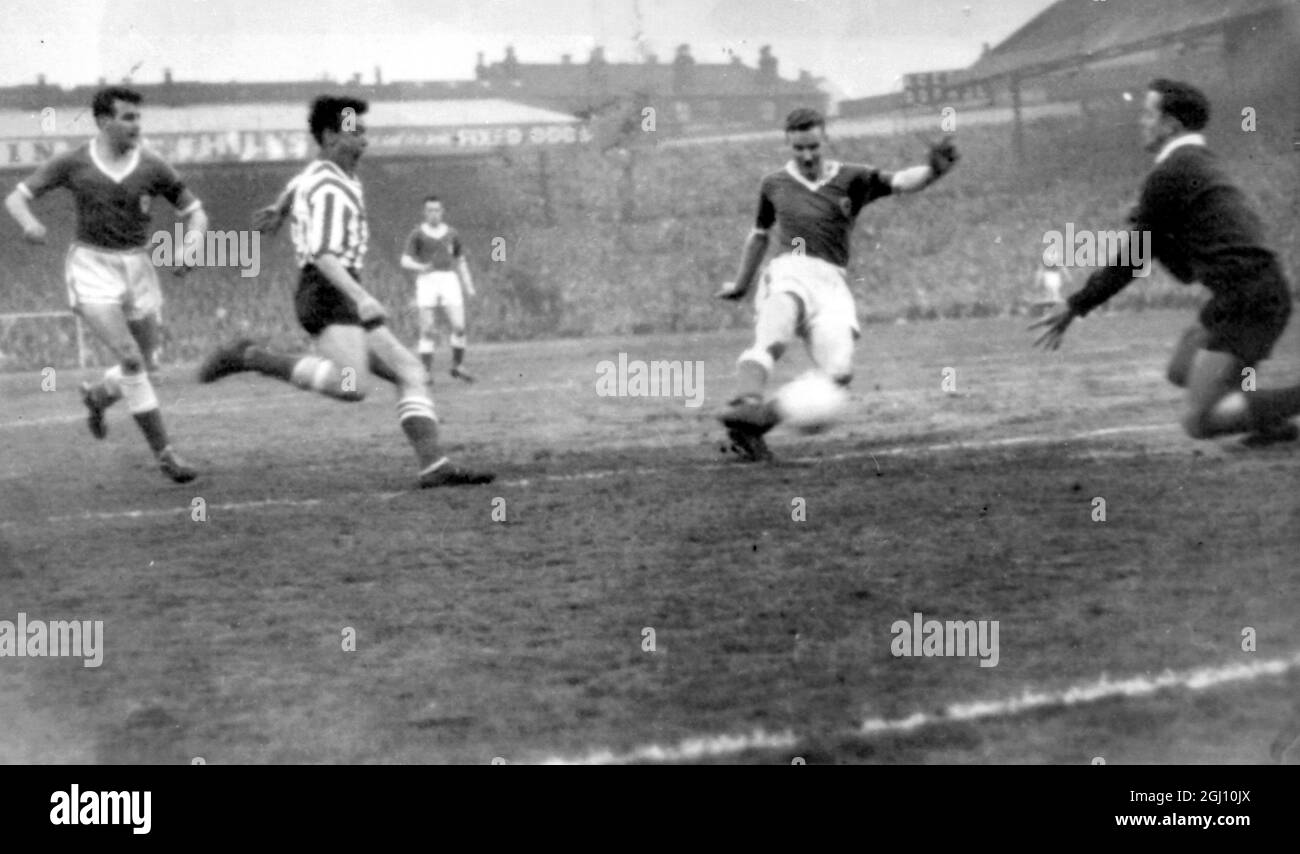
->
[402,195,475,385]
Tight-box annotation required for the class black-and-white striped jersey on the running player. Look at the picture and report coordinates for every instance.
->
[286,160,371,269]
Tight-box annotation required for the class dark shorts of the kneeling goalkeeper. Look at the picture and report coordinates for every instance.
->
[1200,265,1291,365]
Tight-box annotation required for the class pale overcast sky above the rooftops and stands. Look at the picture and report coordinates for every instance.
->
[0,0,1053,96]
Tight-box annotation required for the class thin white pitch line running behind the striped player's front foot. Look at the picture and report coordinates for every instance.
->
[35,424,1173,526]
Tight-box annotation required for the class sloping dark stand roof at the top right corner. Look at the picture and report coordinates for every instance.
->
[954,0,1296,82]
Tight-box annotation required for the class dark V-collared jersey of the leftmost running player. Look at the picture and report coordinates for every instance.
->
[18,143,199,250]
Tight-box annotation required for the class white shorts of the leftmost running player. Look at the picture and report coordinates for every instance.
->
[64,243,163,320]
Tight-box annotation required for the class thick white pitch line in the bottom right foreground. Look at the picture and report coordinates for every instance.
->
[541,653,1300,764]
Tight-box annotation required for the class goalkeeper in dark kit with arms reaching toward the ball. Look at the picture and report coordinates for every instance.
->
[1031,79,1300,445]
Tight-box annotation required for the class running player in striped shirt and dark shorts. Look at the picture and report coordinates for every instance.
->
[199,95,493,487]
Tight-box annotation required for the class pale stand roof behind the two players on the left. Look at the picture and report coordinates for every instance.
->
[0,97,579,139]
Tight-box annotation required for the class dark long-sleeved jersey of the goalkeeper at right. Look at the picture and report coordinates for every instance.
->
[1070,144,1281,315]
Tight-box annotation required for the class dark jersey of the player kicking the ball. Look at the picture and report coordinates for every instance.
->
[754,160,892,266]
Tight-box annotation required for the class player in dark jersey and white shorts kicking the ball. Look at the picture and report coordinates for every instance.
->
[716,108,957,461]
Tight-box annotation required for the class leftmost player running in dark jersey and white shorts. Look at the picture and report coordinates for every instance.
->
[5,86,208,484]
